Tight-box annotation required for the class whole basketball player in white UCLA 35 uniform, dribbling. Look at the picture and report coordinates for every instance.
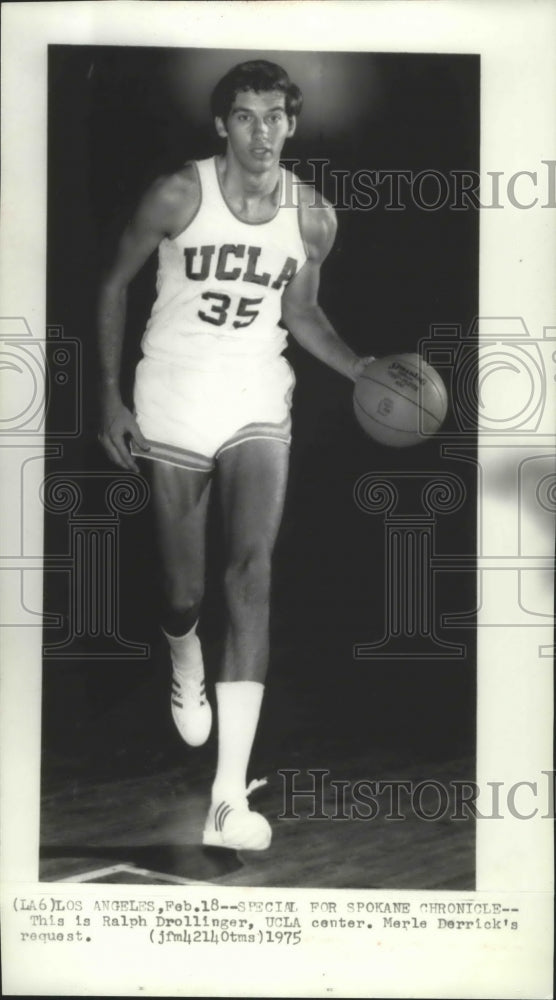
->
[99,61,371,850]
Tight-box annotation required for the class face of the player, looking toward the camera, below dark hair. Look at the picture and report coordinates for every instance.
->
[216,90,295,173]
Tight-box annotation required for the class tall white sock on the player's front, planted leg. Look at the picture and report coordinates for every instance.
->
[212,681,264,803]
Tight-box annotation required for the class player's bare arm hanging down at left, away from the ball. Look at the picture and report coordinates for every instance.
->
[98,167,200,472]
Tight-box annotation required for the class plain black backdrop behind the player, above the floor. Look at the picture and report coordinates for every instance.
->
[43,46,479,783]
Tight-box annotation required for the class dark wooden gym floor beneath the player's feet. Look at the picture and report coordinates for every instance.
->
[40,648,475,890]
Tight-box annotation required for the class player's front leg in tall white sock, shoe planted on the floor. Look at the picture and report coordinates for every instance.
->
[204,439,289,850]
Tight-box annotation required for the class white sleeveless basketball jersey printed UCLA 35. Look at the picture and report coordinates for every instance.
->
[141,157,307,371]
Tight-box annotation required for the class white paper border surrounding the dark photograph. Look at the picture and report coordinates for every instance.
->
[0,0,556,997]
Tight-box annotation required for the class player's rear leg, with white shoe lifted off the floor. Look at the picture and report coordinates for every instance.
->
[152,461,211,746]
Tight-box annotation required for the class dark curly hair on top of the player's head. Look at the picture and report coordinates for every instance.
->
[210,59,303,122]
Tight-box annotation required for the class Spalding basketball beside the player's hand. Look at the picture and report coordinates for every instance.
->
[353,354,448,448]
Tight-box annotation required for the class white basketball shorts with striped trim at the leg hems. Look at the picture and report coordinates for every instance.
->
[131,357,295,472]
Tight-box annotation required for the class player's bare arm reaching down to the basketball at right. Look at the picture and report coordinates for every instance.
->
[282,187,373,381]
